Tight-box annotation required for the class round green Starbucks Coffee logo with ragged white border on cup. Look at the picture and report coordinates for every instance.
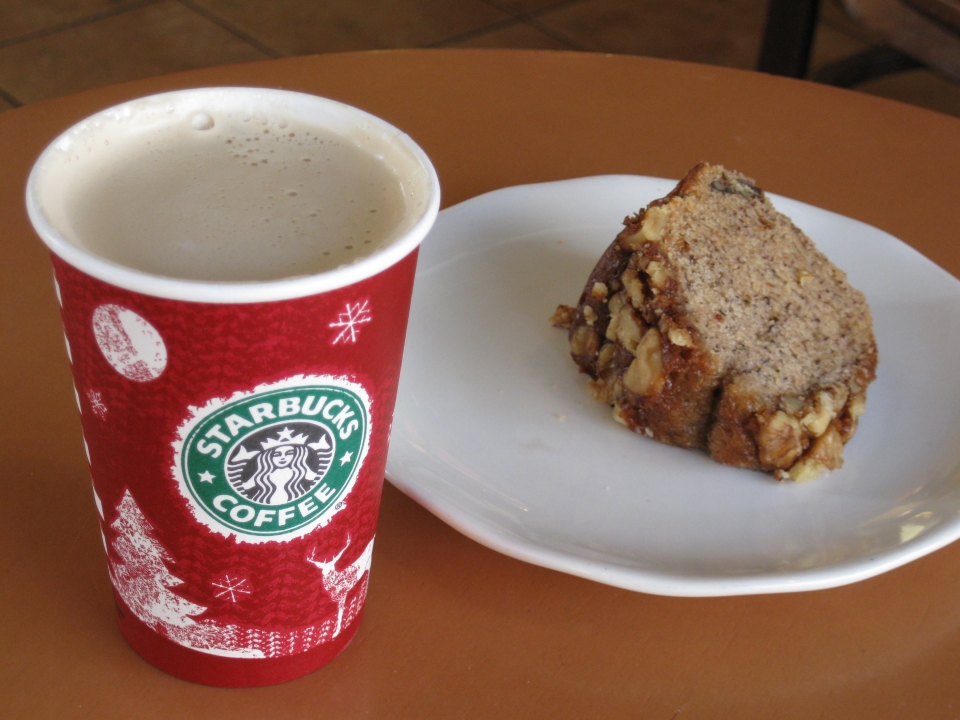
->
[173,376,370,543]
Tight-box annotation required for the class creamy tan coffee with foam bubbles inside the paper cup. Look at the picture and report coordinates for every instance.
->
[37,93,428,281]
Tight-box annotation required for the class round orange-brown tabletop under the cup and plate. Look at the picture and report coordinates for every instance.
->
[0,50,960,720]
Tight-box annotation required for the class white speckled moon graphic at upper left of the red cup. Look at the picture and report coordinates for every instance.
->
[93,305,167,382]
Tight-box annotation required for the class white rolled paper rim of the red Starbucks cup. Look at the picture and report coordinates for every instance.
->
[26,86,440,303]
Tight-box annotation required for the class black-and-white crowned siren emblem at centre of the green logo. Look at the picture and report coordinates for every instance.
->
[225,420,336,505]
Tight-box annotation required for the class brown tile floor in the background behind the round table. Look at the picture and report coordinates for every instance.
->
[0,0,960,116]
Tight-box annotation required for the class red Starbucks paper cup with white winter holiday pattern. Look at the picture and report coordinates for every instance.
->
[27,88,439,687]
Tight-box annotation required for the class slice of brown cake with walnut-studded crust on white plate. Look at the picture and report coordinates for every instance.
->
[553,163,877,481]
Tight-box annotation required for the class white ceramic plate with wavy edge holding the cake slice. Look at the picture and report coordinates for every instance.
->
[387,176,960,596]
